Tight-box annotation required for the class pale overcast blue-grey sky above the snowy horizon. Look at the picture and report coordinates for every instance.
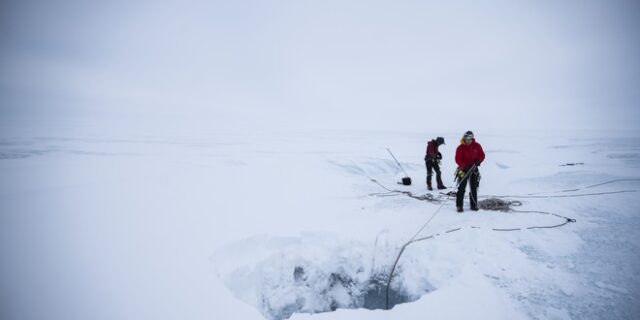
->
[0,0,640,136]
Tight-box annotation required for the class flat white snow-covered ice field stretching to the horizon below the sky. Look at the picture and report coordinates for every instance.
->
[0,131,640,319]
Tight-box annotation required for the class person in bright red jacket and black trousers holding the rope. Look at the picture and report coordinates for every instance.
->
[456,131,484,212]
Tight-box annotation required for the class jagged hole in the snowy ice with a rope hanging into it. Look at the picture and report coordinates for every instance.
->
[219,235,435,320]
